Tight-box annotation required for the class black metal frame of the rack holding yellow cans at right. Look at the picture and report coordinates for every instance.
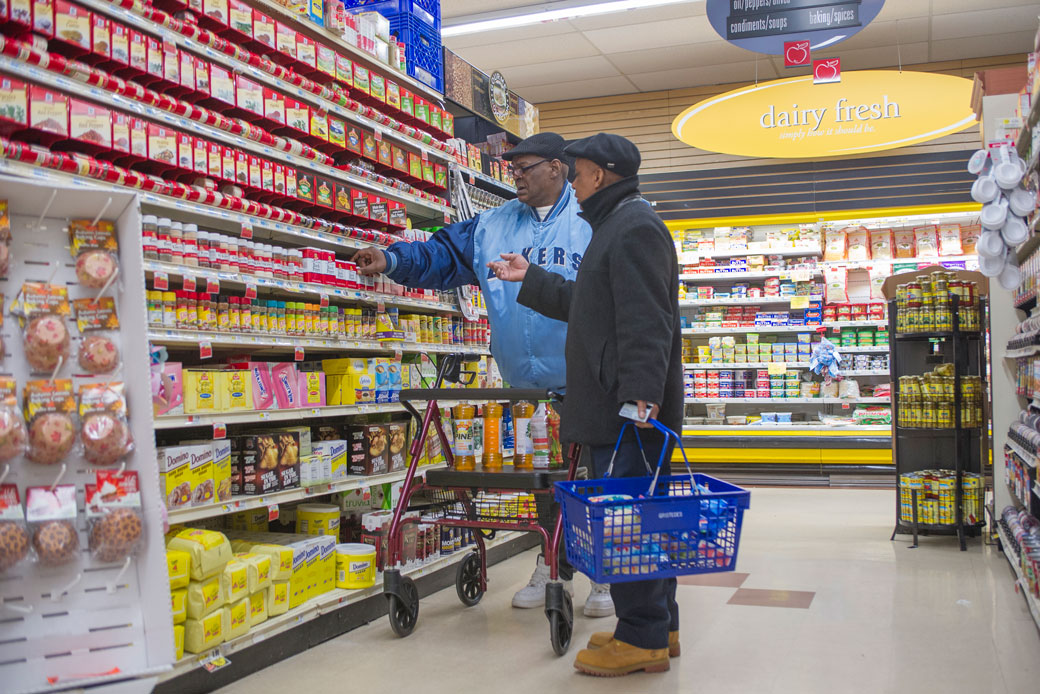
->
[888,298,989,551]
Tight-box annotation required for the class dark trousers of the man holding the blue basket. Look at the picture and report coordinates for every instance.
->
[586,428,679,648]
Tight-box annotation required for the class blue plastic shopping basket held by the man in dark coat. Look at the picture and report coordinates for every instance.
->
[556,419,751,583]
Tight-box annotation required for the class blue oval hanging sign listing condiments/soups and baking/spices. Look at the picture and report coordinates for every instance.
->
[705,0,885,55]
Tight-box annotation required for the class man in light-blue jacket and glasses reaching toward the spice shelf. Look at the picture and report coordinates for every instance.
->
[355,132,614,617]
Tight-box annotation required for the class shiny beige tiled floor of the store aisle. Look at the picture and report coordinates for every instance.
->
[213,489,1040,694]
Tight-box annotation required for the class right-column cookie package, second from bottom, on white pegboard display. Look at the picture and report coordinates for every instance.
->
[79,383,133,465]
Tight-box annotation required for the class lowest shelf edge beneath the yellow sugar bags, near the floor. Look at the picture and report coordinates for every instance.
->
[162,532,521,682]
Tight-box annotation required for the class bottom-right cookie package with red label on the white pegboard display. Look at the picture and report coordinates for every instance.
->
[85,470,144,562]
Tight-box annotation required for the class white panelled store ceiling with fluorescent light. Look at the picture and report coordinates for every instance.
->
[442,0,1040,103]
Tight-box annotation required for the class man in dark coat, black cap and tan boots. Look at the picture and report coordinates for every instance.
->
[489,133,683,675]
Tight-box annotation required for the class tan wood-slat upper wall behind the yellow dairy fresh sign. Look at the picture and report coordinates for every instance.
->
[539,54,1026,174]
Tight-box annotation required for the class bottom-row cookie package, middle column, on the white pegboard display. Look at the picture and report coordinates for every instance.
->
[25,485,79,566]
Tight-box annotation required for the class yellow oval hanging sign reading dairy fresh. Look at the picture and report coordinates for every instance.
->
[672,70,978,159]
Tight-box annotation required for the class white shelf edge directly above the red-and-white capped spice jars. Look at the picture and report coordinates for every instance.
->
[0,158,382,251]
